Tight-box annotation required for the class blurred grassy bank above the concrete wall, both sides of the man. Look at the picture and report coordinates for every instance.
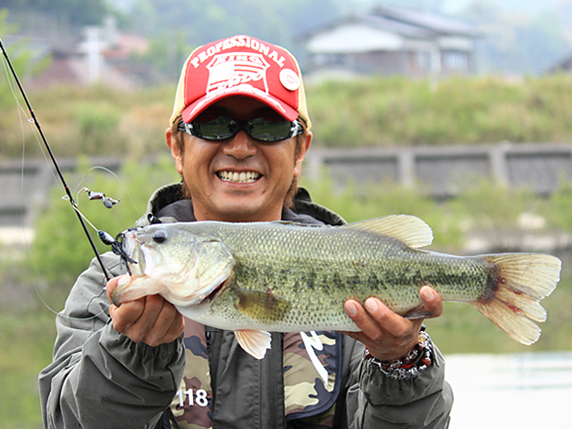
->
[0,74,572,157]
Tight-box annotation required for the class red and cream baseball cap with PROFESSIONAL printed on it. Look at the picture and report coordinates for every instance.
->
[170,35,311,129]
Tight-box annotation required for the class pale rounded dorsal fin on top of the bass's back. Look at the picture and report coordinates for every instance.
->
[341,215,433,249]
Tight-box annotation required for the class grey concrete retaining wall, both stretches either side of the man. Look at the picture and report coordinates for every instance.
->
[4,143,572,227]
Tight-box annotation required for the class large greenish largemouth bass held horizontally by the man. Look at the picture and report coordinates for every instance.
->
[112,215,561,359]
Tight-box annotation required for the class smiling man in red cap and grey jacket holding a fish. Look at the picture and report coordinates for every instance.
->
[40,36,452,428]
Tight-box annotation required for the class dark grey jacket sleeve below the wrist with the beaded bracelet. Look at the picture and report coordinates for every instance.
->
[346,336,453,429]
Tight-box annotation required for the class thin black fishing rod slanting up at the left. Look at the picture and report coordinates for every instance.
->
[0,37,113,281]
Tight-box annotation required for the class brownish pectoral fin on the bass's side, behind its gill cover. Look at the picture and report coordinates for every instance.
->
[234,289,290,321]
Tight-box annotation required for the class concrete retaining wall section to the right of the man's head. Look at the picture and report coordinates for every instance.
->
[306,143,572,198]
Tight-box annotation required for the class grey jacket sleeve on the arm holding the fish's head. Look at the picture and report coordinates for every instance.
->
[39,254,185,429]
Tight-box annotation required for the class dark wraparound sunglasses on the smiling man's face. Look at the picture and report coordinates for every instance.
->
[179,114,304,142]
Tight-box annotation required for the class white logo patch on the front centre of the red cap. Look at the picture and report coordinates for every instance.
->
[206,52,270,93]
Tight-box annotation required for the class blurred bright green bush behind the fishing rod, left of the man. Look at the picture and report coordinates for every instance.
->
[28,157,179,290]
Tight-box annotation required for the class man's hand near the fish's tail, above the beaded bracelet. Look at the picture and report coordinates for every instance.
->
[344,286,443,360]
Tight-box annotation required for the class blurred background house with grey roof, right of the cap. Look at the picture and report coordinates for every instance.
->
[304,7,479,77]
